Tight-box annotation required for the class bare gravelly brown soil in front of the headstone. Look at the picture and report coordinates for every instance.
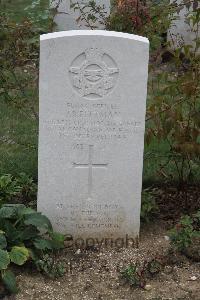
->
[10,222,200,300]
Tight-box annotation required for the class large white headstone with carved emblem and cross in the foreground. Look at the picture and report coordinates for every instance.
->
[38,30,149,238]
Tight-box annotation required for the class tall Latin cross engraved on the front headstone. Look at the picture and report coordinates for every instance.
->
[73,145,108,198]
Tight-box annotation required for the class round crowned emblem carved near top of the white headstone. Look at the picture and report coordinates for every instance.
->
[69,48,119,100]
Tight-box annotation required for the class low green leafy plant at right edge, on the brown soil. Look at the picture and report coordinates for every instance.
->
[169,210,200,252]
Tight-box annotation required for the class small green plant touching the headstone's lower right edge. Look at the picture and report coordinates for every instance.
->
[140,189,158,223]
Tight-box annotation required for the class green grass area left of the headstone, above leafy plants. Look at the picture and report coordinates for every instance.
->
[0,102,38,178]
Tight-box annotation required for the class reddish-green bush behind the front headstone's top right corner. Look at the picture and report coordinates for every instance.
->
[99,0,175,53]
